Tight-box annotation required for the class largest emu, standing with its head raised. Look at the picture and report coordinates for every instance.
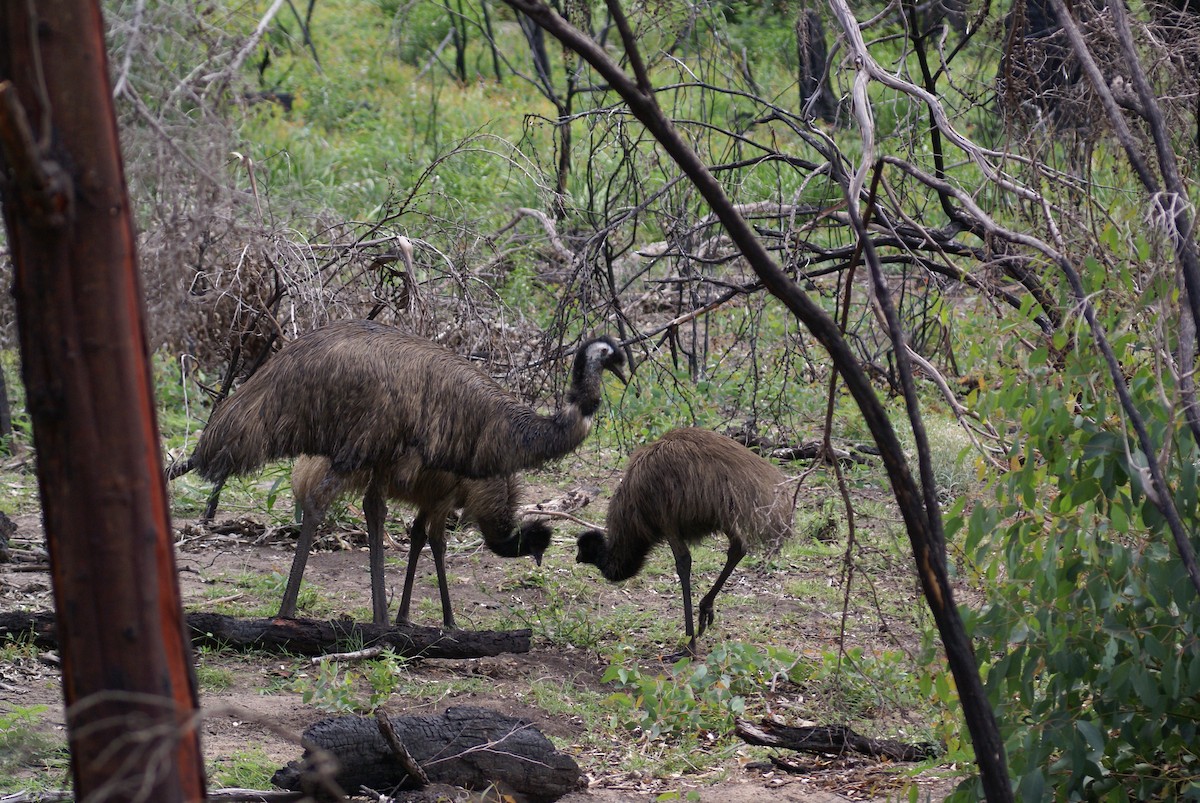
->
[187,320,625,624]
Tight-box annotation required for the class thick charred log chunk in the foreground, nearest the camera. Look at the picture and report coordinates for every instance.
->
[271,706,581,803]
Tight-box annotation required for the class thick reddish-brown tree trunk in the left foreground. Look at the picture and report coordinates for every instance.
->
[0,0,204,802]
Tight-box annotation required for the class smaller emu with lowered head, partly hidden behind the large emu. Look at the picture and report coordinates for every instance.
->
[288,455,551,628]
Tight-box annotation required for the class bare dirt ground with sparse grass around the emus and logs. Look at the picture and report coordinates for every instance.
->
[0,453,961,803]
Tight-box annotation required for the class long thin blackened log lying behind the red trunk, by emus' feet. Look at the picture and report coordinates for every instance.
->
[0,611,533,658]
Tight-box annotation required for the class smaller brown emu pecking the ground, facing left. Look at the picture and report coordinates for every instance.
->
[576,429,792,655]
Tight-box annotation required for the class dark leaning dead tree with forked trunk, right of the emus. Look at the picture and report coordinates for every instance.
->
[489,0,1013,802]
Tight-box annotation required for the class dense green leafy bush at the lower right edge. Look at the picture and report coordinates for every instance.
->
[947,320,1200,799]
